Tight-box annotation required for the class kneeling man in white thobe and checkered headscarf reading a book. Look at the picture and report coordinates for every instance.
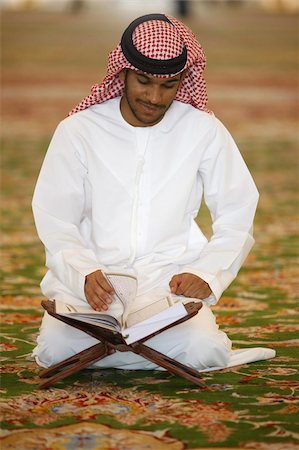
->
[33,14,274,371]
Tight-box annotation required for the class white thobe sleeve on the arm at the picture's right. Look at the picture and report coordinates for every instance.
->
[183,119,258,304]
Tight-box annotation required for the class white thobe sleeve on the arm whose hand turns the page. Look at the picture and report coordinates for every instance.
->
[32,122,101,299]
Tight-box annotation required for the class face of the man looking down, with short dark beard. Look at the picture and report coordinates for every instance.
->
[120,69,182,127]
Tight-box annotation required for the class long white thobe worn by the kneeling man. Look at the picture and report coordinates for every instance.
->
[33,98,273,370]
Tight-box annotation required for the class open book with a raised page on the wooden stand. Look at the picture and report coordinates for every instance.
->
[55,274,191,344]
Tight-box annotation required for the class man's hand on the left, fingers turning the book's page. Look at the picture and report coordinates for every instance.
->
[84,270,114,311]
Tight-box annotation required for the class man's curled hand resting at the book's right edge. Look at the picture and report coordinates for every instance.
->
[169,273,212,299]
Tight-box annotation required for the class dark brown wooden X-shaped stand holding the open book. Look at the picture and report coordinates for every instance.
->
[40,300,207,388]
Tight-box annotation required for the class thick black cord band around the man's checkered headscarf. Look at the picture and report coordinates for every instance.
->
[120,14,187,75]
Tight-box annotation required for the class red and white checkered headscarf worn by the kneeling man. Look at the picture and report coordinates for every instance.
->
[70,15,208,114]
